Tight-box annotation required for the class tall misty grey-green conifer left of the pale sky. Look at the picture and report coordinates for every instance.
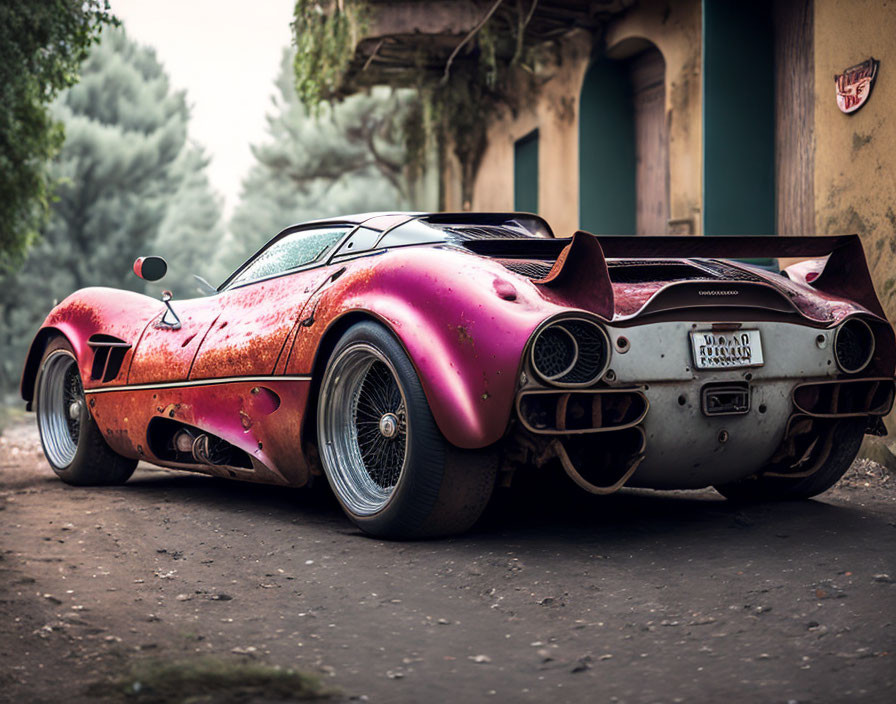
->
[0,29,221,389]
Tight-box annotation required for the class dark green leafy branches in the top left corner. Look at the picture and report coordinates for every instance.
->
[0,0,116,272]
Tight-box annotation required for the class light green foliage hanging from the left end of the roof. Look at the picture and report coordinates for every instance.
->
[292,0,367,108]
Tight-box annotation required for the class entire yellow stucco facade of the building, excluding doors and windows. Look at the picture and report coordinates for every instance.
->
[452,0,896,322]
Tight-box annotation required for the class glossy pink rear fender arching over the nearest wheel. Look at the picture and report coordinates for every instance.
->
[286,247,565,448]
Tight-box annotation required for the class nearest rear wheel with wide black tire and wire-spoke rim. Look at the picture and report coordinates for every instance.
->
[317,322,497,539]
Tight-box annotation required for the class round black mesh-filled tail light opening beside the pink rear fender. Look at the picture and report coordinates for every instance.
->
[531,318,610,387]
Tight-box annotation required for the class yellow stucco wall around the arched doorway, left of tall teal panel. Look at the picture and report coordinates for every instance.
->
[456,0,702,235]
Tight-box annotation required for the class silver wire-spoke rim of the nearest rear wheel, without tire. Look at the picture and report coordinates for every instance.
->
[319,342,410,516]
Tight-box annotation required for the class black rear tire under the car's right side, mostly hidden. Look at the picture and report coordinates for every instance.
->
[713,418,866,502]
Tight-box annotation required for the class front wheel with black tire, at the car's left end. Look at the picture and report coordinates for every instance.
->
[34,337,137,486]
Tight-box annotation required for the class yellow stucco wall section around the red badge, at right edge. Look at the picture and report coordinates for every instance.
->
[814,0,896,323]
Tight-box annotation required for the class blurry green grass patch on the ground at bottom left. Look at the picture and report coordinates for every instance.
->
[87,658,334,704]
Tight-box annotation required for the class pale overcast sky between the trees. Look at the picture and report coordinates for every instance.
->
[111,0,295,214]
